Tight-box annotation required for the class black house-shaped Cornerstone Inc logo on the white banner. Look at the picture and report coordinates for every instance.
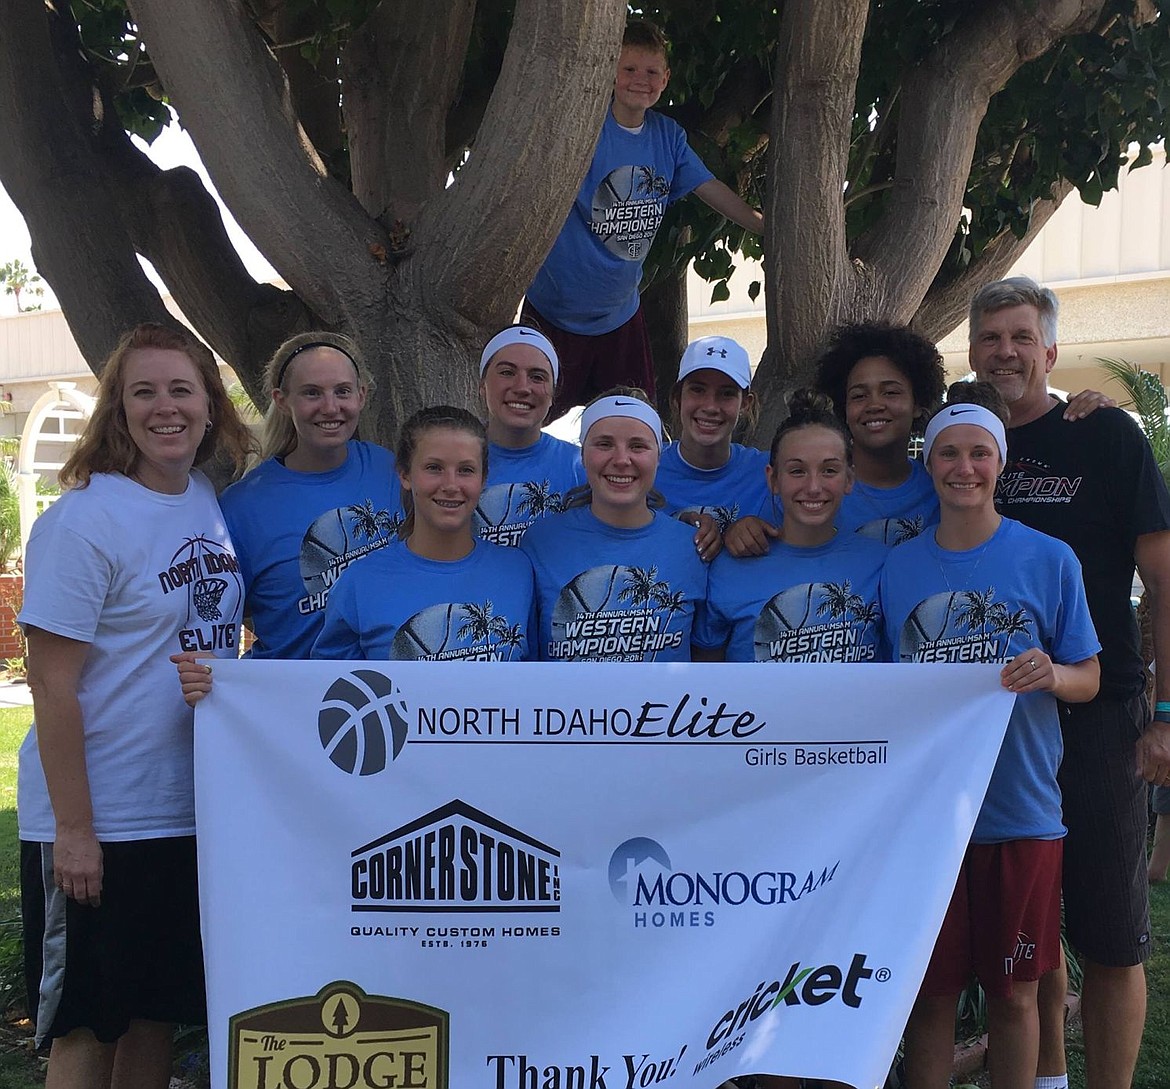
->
[350,799,560,912]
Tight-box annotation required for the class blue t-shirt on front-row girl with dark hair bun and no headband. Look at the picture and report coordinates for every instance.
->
[695,532,887,662]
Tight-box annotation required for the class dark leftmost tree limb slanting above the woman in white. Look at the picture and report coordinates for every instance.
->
[0,0,178,371]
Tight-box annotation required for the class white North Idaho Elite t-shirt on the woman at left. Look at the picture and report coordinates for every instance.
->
[16,473,242,842]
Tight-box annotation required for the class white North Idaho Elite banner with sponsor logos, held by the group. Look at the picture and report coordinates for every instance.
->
[195,661,1013,1089]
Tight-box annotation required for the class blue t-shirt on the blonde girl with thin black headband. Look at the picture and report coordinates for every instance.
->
[220,440,402,659]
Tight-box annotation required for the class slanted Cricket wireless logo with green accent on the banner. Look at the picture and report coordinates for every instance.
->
[695,953,890,1074]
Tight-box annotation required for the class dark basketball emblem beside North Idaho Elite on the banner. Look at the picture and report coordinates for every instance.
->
[317,669,410,776]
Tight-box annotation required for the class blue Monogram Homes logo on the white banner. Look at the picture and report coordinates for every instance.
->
[608,836,840,929]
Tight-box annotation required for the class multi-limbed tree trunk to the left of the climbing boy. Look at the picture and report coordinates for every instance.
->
[0,0,626,442]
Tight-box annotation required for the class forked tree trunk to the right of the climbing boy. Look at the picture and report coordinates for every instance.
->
[757,0,1103,434]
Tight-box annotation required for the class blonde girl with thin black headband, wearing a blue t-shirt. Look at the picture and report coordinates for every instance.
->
[220,332,401,659]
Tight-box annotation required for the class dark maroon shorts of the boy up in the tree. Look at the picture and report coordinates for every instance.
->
[521,301,654,420]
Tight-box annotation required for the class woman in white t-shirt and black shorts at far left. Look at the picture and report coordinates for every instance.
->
[18,325,250,1089]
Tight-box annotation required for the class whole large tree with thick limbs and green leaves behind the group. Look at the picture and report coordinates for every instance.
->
[0,0,1170,441]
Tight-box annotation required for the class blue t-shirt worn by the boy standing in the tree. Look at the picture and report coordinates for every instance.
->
[528,110,713,337]
